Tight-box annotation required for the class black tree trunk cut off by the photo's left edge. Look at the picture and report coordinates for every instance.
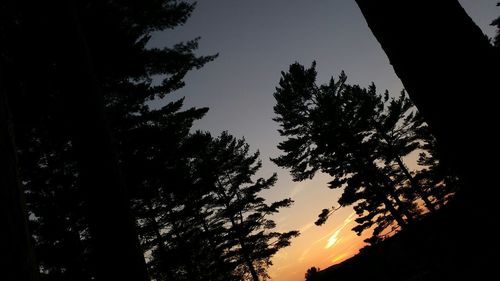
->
[0,61,38,281]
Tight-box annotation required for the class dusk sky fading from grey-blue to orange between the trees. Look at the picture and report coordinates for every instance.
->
[150,0,500,281]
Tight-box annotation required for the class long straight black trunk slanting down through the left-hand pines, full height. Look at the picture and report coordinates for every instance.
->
[49,0,149,281]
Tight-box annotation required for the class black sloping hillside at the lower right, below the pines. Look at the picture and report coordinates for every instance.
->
[311,198,494,281]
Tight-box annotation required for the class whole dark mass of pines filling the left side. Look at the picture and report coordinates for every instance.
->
[0,0,298,281]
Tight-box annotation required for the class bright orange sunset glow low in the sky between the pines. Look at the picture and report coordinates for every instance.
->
[269,176,367,281]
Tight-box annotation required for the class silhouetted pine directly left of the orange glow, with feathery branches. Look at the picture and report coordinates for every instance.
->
[196,132,299,281]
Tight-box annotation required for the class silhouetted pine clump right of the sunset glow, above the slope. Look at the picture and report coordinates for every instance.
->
[272,63,454,240]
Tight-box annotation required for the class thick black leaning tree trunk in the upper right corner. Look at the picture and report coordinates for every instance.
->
[356,0,500,208]
